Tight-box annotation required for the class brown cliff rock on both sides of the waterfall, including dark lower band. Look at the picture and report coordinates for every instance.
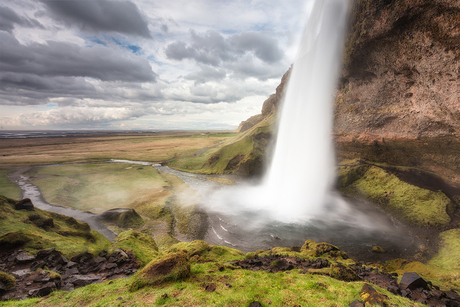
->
[234,0,460,180]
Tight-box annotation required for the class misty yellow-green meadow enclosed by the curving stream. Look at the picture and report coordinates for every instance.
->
[27,163,169,213]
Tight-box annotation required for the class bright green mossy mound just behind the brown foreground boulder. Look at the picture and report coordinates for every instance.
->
[113,230,159,266]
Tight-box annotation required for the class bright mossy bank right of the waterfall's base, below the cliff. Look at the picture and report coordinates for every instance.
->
[339,165,450,226]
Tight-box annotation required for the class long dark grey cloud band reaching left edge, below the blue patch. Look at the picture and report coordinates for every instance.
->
[0,32,156,82]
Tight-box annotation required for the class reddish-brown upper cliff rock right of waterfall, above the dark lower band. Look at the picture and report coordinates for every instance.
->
[334,0,460,140]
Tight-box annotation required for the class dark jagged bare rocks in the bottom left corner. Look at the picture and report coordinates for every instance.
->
[0,248,139,300]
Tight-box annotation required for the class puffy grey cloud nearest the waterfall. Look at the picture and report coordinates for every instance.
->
[165,30,283,66]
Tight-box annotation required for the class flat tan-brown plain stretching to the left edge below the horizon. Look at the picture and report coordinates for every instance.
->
[0,132,233,166]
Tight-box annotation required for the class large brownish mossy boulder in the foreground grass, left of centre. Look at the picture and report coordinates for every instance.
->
[130,253,190,291]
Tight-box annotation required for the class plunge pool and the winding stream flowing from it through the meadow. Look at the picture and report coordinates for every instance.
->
[9,160,420,260]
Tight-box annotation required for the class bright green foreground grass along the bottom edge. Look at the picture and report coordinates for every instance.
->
[0,263,421,307]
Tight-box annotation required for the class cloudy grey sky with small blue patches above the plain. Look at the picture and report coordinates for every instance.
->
[0,0,309,130]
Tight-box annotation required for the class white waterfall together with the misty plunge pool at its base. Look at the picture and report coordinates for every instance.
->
[204,0,415,256]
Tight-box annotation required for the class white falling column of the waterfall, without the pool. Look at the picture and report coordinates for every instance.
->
[263,0,348,223]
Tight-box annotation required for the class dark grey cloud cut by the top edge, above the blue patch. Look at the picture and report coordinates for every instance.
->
[42,0,151,38]
